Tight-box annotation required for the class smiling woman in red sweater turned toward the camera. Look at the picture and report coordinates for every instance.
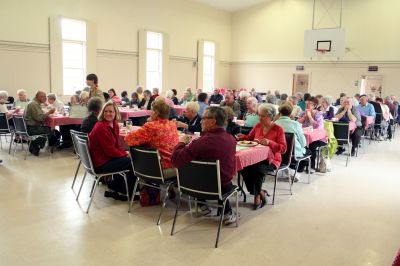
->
[89,101,134,200]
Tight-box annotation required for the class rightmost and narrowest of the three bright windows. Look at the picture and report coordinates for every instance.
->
[203,42,215,92]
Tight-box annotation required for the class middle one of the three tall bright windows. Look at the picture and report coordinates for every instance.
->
[146,32,163,92]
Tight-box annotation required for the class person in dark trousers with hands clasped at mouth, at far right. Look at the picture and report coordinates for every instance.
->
[335,96,363,156]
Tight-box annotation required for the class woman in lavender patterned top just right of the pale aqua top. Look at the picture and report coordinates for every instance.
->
[297,97,324,129]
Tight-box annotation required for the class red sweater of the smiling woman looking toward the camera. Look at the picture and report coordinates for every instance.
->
[89,121,127,168]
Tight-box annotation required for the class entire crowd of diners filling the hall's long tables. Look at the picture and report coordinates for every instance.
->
[0,74,399,220]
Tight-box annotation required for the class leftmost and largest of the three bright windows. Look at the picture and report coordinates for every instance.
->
[61,19,86,95]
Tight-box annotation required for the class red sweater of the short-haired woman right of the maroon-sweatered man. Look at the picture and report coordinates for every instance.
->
[244,123,286,168]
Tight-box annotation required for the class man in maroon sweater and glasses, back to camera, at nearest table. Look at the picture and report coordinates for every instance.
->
[172,107,236,225]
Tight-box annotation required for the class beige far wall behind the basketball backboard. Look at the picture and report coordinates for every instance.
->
[230,0,400,95]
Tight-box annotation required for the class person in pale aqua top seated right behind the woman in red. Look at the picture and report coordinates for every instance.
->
[275,103,311,181]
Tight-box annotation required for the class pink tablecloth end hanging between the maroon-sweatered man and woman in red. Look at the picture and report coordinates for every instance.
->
[235,145,274,172]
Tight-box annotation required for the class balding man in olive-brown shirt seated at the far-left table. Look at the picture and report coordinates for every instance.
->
[24,91,57,156]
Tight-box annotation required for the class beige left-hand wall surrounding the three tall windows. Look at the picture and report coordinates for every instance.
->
[0,0,231,98]
